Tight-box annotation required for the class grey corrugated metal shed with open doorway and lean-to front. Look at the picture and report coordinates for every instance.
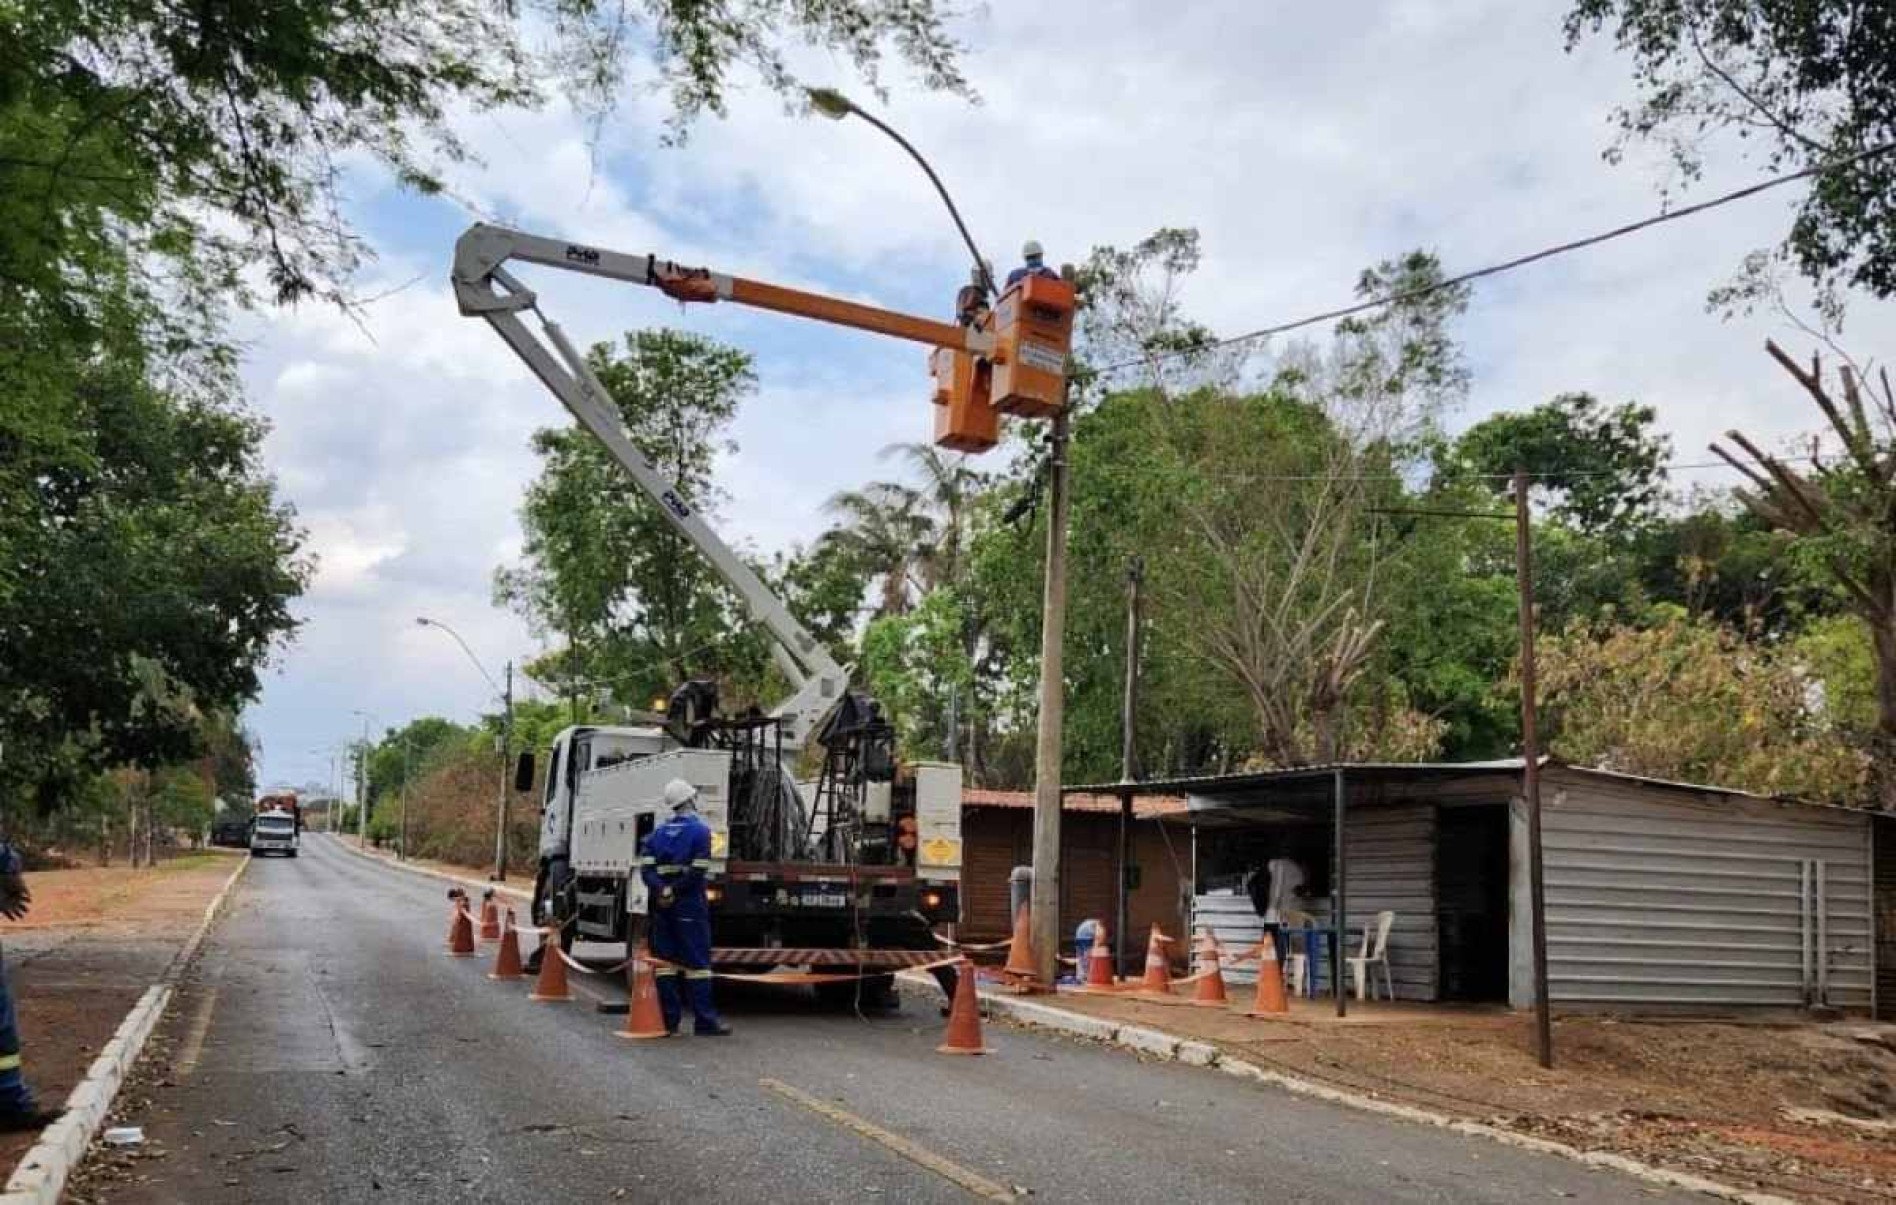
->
[1141,760,1896,1012]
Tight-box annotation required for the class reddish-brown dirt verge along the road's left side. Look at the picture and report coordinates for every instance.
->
[0,851,243,1169]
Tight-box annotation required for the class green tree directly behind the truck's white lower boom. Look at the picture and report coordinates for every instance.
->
[495,330,766,707]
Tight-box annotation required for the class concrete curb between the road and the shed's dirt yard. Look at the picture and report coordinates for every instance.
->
[963,980,1794,1205]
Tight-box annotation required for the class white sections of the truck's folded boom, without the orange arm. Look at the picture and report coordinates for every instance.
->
[453,224,849,748]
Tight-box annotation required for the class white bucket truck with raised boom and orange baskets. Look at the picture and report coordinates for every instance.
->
[453,224,1073,991]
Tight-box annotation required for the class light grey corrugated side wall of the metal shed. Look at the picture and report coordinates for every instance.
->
[1513,767,1871,1008]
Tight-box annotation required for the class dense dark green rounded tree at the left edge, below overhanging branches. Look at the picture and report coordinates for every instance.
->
[0,356,309,805]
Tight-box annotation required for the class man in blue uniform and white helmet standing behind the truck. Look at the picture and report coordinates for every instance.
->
[639,779,730,1038]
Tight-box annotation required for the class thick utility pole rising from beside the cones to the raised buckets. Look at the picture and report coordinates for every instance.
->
[1031,398,1069,983]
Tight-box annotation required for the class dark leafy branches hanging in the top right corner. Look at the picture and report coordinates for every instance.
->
[1566,0,1896,316]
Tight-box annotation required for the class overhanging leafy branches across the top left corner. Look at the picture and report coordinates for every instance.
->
[0,0,969,312]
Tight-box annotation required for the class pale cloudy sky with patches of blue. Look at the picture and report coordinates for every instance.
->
[245,0,1896,782]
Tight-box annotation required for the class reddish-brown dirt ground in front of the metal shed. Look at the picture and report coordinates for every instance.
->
[1056,991,1896,1201]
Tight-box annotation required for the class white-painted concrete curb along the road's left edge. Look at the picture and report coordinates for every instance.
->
[0,854,250,1205]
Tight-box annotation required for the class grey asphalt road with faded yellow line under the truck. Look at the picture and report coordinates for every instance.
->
[82,837,1687,1205]
